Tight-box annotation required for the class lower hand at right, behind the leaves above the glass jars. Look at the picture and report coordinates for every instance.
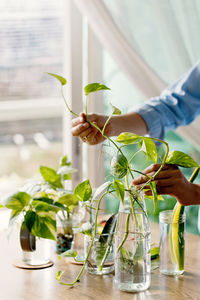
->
[133,164,197,205]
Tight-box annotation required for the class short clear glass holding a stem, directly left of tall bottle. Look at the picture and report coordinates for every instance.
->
[84,233,114,275]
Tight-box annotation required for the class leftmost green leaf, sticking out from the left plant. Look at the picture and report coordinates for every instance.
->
[4,192,31,212]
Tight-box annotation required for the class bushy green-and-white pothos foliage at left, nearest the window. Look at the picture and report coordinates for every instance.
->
[3,155,79,246]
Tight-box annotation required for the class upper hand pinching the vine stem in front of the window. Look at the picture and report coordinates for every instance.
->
[72,113,111,145]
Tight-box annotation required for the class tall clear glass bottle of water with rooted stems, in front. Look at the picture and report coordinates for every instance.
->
[115,208,151,292]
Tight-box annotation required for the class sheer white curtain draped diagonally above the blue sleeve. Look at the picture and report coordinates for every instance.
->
[75,0,200,148]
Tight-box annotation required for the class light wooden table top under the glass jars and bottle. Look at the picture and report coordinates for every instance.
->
[0,224,200,300]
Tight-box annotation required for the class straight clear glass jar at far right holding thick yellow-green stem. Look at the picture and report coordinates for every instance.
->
[159,210,186,275]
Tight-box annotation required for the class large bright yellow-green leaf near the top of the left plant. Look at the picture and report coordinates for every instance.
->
[40,166,63,188]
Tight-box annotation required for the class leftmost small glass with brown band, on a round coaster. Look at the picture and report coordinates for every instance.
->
[20,224,51,266]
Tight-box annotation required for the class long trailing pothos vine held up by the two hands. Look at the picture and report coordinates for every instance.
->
[48,73,200,286]
